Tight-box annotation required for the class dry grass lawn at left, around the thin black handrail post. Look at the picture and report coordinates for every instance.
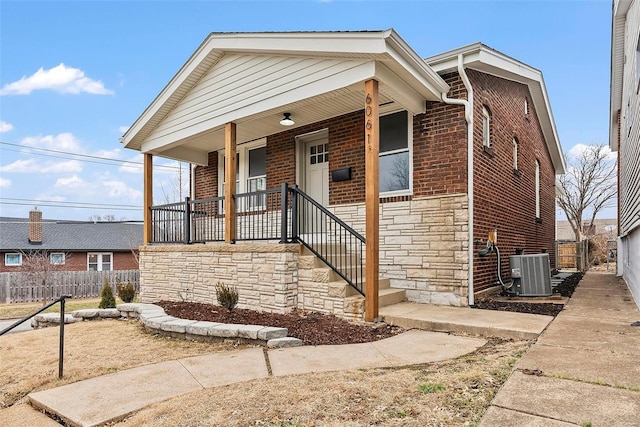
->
[0,320,249,408]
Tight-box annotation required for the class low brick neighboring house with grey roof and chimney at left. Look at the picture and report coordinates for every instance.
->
[0,210,143,272]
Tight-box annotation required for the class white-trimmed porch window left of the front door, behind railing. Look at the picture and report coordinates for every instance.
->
[218,138,267,211]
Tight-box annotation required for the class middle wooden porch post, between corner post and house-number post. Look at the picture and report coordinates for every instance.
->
[224,123,236,243]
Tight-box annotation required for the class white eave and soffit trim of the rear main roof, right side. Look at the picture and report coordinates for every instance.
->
[425,43,566,174]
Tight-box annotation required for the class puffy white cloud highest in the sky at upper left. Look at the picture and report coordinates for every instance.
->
[0,63,113,95]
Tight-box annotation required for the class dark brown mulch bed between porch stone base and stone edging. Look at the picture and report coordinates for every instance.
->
[155,301,403,345]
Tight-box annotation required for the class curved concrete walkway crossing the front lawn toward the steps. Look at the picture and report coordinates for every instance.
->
[26,330,486,426]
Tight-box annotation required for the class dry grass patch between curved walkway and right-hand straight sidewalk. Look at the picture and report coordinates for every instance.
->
[117,341,530,427]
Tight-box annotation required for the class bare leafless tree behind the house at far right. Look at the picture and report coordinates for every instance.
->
[557,145,617,270]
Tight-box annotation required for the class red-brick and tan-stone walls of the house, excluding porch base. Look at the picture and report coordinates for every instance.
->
[184,70,555,305]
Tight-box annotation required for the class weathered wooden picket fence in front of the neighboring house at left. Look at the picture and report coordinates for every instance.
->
[0,270,140,303]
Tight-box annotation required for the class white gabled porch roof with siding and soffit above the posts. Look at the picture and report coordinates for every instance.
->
[121,29,449,164]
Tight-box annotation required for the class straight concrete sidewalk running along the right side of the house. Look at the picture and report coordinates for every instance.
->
[480,272,640,427]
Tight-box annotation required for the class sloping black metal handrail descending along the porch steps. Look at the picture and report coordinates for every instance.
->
[289,185,365,295]
